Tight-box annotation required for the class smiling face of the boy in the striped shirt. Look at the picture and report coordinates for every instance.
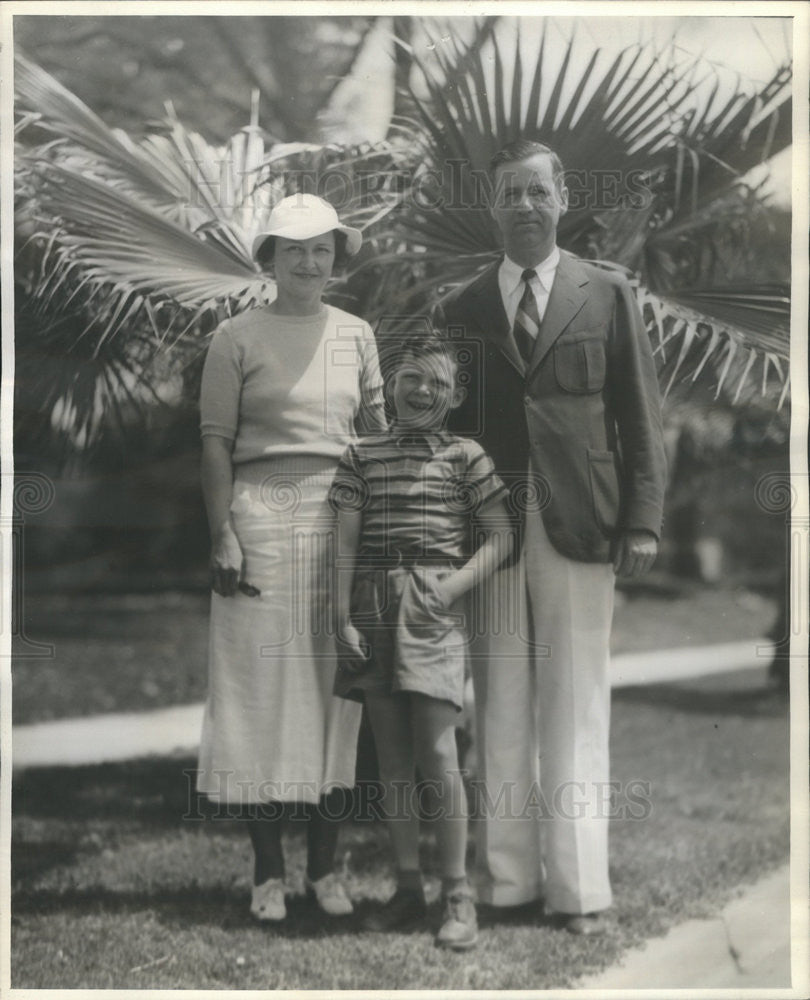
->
[391,354,464,430]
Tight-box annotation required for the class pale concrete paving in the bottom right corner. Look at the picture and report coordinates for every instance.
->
[576,865,796,996]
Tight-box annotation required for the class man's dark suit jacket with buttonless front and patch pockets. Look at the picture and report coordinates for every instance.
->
[436,252,666,562]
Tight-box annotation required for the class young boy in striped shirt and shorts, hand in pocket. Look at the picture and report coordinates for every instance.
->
[330,337,508,950]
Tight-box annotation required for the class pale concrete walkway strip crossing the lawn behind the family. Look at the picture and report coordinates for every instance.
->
[11,639,773,768]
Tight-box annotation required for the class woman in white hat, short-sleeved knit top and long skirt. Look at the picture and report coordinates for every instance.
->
[197,194,384,920]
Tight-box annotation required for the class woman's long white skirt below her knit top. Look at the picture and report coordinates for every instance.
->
[197,456,361,804]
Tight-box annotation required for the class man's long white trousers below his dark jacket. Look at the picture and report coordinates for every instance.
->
[471,500,614,913]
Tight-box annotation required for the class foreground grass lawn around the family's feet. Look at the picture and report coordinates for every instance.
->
[11,668,789,990]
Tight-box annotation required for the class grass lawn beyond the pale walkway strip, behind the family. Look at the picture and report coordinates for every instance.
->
[12,577,776,725]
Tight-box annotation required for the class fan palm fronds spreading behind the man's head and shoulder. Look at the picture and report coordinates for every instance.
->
[388,22,790,395]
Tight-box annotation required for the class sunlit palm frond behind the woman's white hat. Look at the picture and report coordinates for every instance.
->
[17,58,410,360]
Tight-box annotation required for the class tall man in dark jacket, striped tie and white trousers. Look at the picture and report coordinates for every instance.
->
[443,140,665,934]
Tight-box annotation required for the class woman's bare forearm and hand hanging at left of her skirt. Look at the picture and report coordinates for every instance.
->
[201,434,244,597]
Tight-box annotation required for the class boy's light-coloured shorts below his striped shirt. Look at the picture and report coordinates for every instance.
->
[334,565,468,711]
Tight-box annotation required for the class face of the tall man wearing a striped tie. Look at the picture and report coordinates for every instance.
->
[491,153,568,267]
